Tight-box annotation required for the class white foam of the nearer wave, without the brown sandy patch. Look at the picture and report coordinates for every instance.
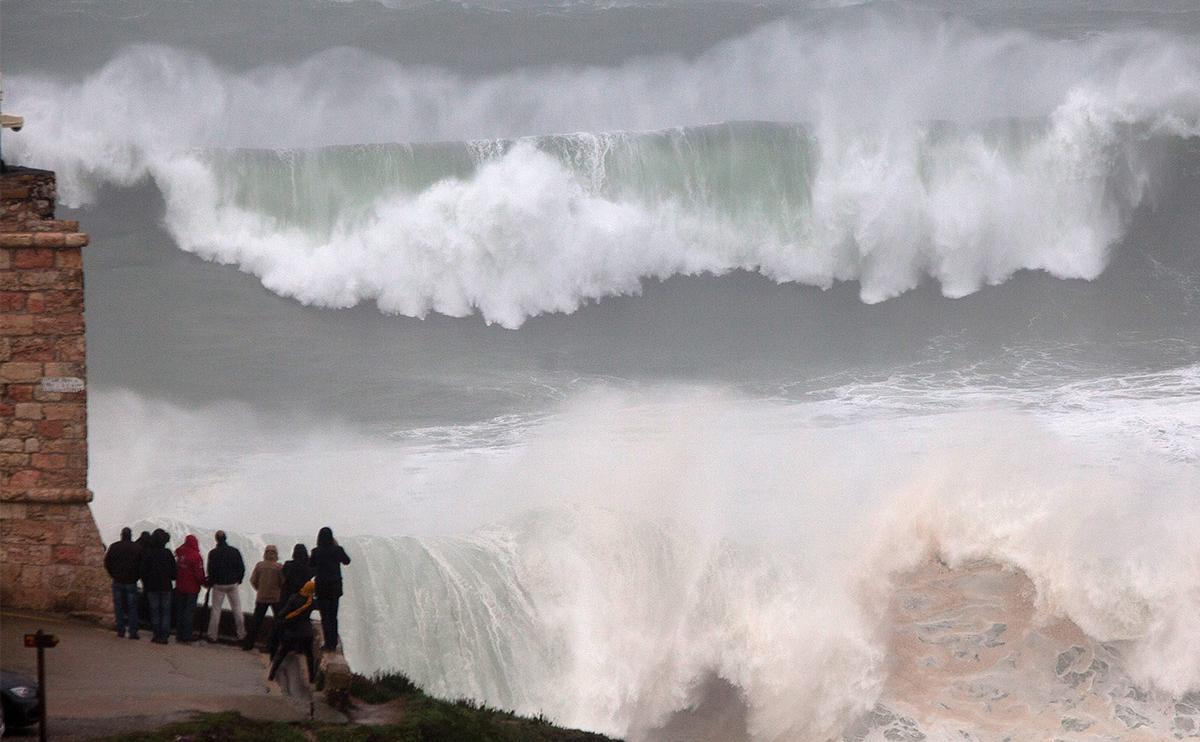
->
[94,372,1200,740]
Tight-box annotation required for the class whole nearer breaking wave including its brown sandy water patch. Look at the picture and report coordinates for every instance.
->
[97,384,1200,740]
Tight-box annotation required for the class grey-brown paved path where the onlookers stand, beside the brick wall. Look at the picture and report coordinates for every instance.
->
[0,611,325,740]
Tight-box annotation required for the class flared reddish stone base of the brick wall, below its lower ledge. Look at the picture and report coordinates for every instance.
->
[0,502,113,621]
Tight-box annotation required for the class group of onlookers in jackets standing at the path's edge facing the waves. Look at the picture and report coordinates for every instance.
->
[104,527,350,680]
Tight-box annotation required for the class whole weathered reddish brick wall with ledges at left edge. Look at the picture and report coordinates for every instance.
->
[0,168,112,617]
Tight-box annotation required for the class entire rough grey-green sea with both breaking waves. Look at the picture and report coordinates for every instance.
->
[0,0,1200,741]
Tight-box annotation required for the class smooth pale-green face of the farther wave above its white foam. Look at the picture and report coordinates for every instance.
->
[200,122,816,237]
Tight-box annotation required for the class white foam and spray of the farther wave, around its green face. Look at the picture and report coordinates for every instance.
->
[8,16,1200,327]
